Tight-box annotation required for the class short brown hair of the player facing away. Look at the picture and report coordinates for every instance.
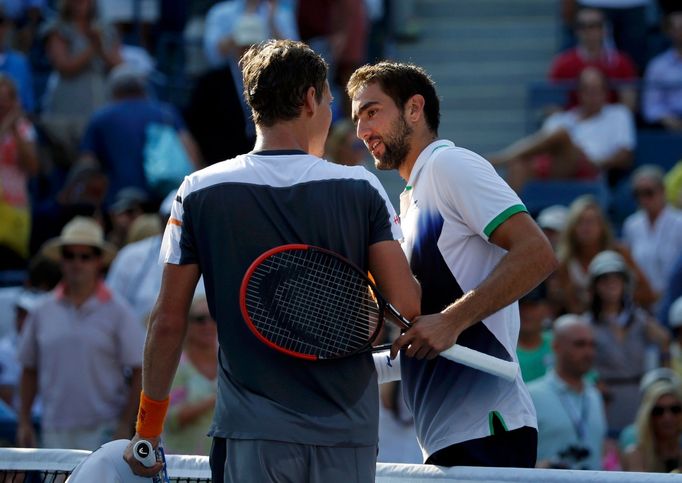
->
[239,40,327,127]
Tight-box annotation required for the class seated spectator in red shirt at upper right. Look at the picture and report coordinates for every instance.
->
[549,8,637,111]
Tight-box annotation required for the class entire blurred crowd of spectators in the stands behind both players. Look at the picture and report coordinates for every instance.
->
[0,0,682,471]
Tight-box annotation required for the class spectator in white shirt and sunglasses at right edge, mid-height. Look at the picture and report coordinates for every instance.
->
[623,164,682,297]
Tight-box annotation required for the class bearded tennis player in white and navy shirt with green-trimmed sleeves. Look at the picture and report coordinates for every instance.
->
[347,62,556,467]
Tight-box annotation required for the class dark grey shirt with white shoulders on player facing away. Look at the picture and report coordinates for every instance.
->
[161,151,399,444]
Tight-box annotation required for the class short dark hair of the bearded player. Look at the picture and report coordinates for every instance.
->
[346,62,440,135]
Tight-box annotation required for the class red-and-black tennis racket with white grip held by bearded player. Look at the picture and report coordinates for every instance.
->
[240,244,519,381]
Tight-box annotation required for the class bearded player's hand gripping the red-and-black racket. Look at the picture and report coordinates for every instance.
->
[391,313,463,359]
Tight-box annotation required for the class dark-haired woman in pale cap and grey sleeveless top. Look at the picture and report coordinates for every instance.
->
[588,250,669,437]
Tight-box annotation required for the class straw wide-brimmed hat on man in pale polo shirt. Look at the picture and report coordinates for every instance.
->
[42,216,116,264]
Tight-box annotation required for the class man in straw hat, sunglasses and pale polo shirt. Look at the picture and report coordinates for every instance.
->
[17,217,144,450]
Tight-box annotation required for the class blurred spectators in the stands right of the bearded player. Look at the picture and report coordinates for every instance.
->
[496,0,682,472]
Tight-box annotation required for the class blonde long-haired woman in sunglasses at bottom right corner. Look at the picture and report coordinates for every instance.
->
[622,380,682,473]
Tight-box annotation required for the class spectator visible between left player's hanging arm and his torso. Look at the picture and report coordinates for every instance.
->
[164,295,218,456]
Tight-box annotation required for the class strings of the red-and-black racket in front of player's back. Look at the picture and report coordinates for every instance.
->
[246,250,380,357]
